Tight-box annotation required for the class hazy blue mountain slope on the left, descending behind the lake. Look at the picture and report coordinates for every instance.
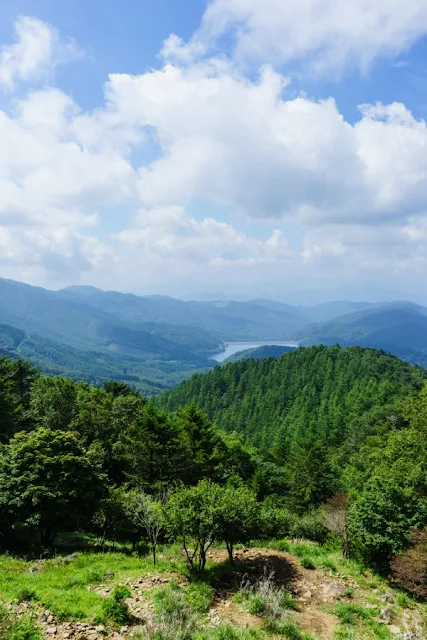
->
[0,279,310,392]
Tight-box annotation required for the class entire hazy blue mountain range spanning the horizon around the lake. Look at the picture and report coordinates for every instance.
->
[0,279,427,395]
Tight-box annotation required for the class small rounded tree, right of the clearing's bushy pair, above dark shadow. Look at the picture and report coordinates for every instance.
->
[217,486,261,562]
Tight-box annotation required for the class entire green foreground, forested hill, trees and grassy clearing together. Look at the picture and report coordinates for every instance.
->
[0,350,427,640]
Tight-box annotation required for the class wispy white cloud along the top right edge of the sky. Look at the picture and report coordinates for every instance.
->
[162,0,427,74]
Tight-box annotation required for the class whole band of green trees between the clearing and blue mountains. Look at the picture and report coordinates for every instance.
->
[0,347,427,596]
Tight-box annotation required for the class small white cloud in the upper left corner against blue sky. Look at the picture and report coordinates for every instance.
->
[0,16,82,89]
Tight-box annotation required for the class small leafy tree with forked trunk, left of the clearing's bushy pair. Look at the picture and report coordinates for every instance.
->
[167,480,223,570]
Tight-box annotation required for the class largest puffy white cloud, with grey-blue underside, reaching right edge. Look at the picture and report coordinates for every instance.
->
[104,65,427,226]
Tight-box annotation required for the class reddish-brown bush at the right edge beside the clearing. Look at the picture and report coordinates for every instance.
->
[391,528,427,600]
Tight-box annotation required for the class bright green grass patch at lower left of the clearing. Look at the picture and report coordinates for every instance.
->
[0,553,183,620]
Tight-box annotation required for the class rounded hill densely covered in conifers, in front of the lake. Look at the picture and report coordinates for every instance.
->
[158,346,426,464]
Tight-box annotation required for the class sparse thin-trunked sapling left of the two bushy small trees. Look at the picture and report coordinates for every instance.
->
[129,491,168,564]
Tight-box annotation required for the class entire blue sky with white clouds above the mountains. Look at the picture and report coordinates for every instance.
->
[0,0,427,302]
